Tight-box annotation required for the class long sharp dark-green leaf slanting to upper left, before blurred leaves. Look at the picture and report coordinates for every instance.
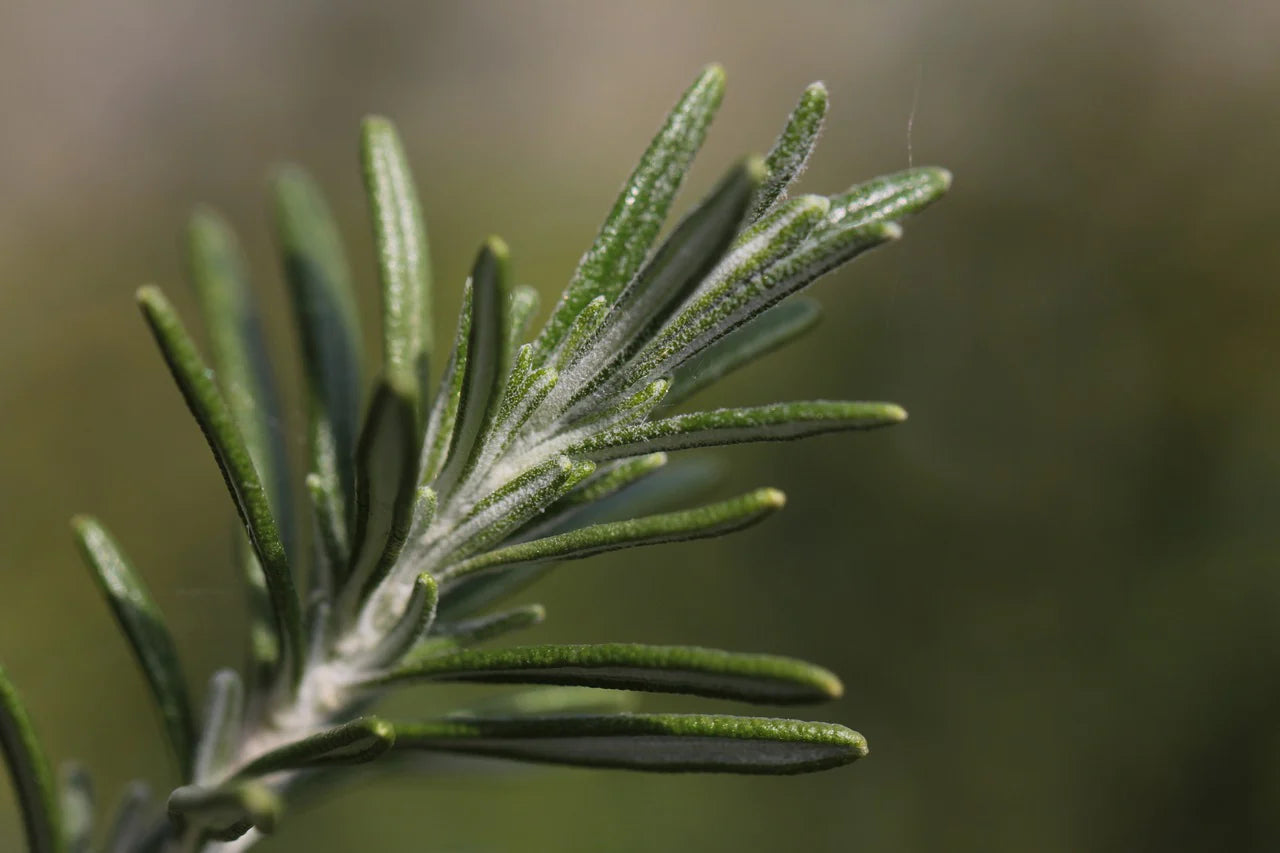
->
[138,287,302,681]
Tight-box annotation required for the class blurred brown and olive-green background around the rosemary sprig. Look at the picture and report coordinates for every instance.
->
[0,0,1280,853]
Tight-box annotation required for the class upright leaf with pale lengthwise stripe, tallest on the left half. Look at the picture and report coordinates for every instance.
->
[361,117,431,414]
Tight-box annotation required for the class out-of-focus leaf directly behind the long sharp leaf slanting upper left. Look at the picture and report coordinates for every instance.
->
[187,209,294,683]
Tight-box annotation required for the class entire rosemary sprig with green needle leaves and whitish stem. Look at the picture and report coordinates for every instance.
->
[0,67,950,853]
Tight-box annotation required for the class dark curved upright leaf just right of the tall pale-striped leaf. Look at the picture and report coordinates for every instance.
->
[434,237,511,497]
